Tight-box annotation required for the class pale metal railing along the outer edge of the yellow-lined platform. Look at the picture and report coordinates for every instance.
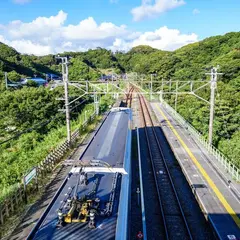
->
[162,100,240,181]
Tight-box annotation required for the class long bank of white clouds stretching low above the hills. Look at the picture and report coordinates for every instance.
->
[0,11,198,55]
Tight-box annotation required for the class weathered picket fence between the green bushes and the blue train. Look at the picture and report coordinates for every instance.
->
[0,112,96,225]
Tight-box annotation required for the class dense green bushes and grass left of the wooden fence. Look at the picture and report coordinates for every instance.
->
[0,87,113,204]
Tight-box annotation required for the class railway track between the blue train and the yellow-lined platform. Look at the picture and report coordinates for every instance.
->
[138,94,193,240]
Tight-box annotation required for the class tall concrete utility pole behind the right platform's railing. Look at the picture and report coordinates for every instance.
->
[207,67,222,145]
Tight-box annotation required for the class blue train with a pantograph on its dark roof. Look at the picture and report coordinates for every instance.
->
[28,109,131,240]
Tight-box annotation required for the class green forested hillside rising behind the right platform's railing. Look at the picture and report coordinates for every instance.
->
[116,32,240,167]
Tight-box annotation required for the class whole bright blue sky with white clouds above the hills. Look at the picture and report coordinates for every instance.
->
[0,0,240,55]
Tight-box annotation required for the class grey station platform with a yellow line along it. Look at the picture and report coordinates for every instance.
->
[151,102,240,240]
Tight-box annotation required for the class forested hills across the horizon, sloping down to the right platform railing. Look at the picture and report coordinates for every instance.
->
[0,32,240,165]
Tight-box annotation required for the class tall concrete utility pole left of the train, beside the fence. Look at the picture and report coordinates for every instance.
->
[57,56,71,145]
